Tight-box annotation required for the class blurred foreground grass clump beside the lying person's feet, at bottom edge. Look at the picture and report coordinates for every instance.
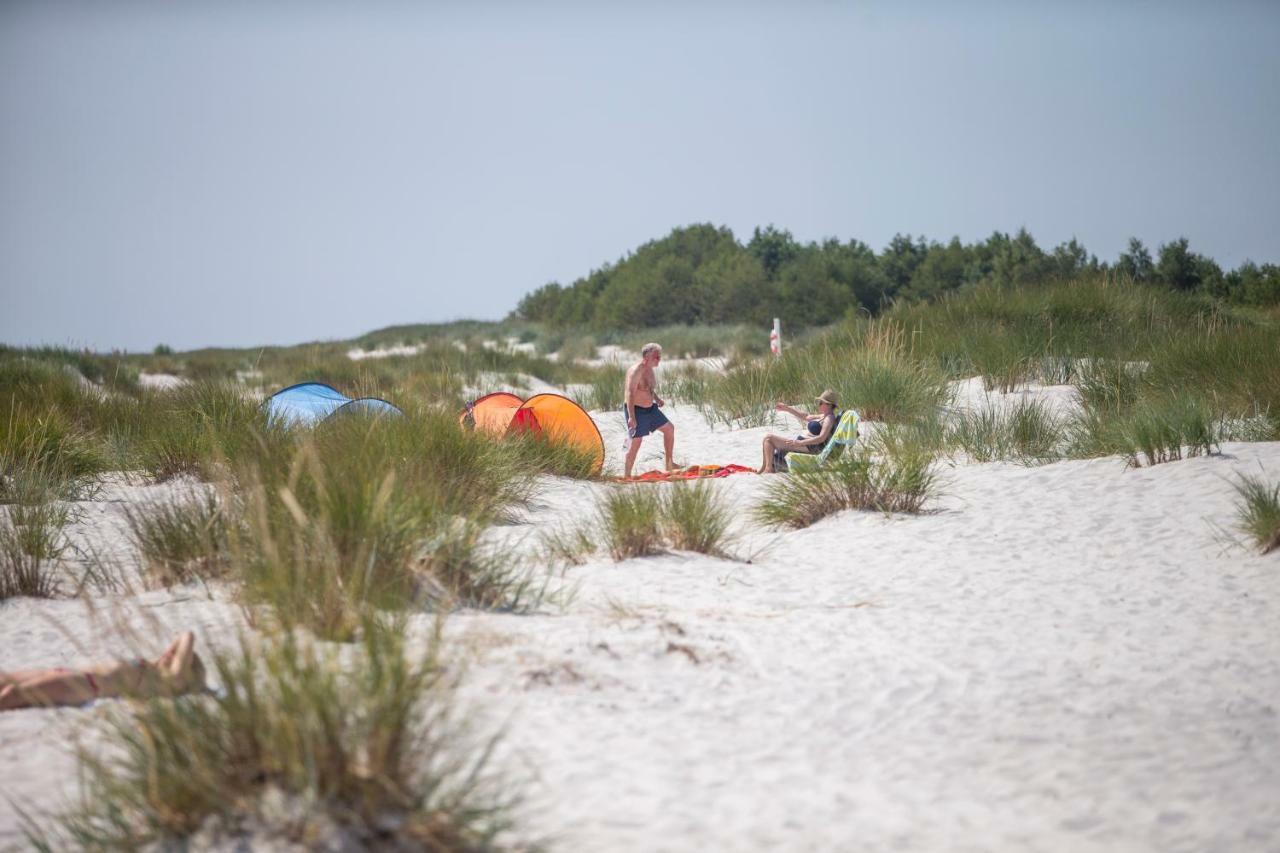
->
[37,621,515,850]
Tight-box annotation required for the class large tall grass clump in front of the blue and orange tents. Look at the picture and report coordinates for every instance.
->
[229,411,565,639]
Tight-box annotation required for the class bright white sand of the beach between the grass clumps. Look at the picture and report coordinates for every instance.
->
[0,388,1280,852]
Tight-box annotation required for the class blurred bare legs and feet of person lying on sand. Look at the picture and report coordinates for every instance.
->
[0,631,205,711]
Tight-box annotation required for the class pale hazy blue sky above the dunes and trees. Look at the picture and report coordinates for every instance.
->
[0,3,1280,350]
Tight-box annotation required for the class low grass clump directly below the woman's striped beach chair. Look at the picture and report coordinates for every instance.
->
[754,444,937,529]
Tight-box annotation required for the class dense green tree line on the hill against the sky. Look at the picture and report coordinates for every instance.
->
[512,224,1280,329]
